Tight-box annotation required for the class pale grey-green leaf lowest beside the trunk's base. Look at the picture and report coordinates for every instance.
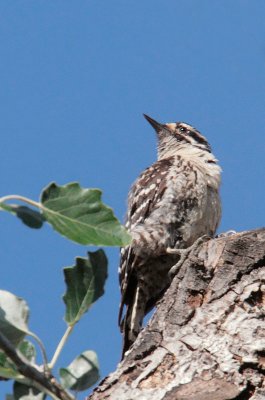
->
[59,350,99,391]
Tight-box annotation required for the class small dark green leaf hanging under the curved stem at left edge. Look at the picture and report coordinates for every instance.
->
[0,203,45,229]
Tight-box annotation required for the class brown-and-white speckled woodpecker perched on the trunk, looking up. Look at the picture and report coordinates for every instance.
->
[119,114,221,359]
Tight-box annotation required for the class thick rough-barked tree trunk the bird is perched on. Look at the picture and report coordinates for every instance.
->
[89,229,265,400]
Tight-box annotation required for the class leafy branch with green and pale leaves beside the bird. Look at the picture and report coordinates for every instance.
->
[0,183,130,400]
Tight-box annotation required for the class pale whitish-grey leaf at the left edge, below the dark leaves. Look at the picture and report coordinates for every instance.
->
[0,290,29,346]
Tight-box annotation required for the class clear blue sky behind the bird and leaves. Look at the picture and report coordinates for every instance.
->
[0,0,265,398]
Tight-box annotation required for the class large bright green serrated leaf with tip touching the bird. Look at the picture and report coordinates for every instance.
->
[40,183,131,246]
